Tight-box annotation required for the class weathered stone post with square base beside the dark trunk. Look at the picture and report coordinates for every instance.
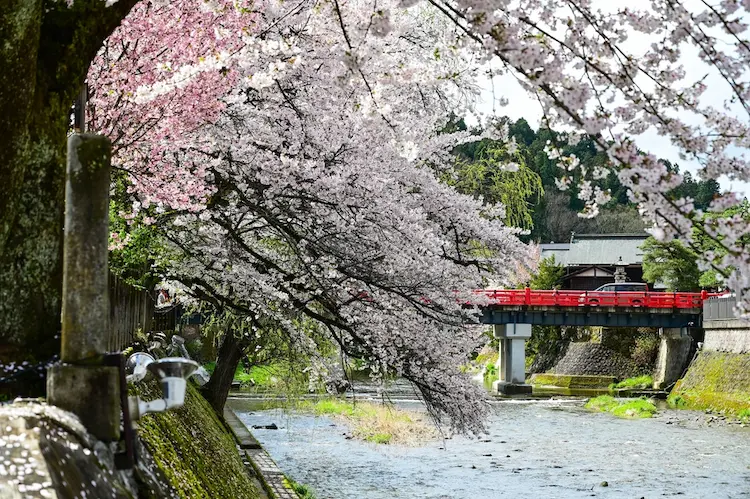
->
[47,134,120,440]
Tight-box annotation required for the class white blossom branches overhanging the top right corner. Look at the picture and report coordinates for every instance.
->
[431,0,750,312]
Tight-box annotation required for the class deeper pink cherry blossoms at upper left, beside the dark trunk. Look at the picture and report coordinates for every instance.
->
[87,0,257,213]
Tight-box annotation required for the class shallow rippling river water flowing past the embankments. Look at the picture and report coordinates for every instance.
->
[230,399,750,499]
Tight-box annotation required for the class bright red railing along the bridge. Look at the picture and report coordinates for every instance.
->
[476,288,720,308]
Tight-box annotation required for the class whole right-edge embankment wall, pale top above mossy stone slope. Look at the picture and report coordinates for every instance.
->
[669,320,750,415]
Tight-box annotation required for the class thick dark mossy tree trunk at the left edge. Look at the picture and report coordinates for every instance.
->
[0,0,138,395]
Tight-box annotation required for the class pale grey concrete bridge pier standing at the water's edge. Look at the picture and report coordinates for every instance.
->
[493,324,531,395]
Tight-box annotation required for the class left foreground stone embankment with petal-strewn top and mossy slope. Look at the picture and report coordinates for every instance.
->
[0,383,265,499]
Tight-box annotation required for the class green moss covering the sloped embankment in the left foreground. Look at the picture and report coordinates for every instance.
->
[130,382,259,499]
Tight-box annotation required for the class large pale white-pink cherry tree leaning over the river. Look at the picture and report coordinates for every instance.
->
[98,2,532,431]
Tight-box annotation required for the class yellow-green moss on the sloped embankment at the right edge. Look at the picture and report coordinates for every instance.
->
[667,351,750,416]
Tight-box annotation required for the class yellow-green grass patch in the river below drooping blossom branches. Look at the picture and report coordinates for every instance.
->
[299,399,438,445]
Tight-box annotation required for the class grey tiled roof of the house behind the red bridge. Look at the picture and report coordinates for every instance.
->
[541,234,649,265]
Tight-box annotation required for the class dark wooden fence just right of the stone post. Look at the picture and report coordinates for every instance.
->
[107,273,154,352]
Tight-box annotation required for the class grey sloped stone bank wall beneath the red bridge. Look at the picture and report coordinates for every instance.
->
[553,343,638,379]
